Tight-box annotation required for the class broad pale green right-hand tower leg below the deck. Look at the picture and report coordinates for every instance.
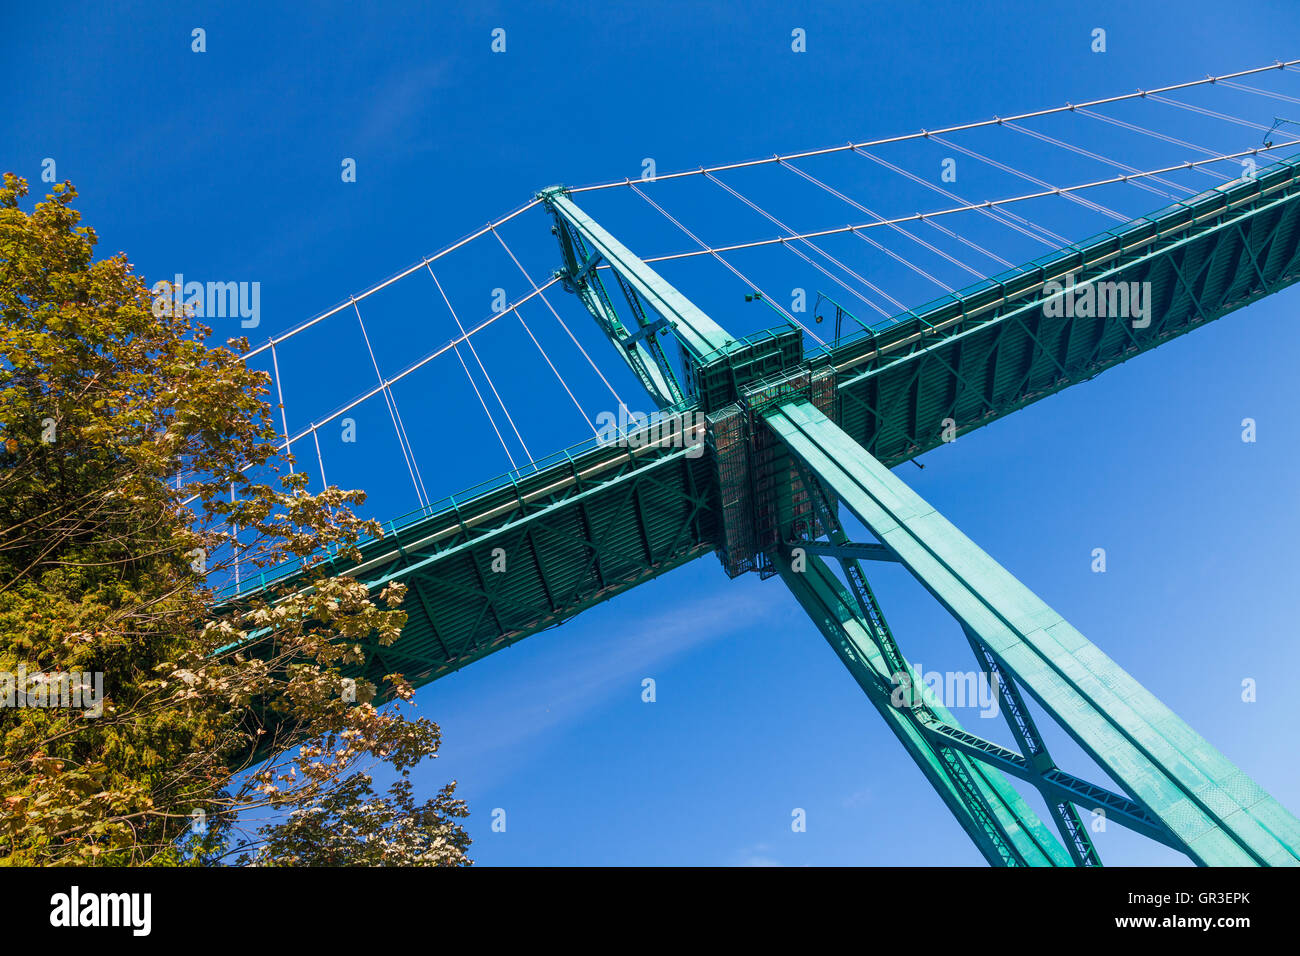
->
[766,401,1300,865]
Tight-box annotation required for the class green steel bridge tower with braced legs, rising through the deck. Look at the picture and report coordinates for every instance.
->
[540,186,1300,866]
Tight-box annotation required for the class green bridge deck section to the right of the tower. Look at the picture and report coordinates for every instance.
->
[826,157,1300,467]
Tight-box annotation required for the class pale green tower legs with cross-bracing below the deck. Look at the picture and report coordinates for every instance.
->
[762,398,1300,866]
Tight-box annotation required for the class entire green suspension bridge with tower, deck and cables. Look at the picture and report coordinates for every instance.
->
[208,61,1300,866]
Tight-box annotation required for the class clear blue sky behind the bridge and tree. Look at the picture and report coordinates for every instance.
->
[0,0,1300,865]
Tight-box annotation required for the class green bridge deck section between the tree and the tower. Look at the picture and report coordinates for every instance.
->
[222,421,716,685]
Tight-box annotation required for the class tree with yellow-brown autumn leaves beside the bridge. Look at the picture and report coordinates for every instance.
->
[0,174,469,865]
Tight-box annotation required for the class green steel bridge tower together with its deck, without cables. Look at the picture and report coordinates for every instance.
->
[228,76,1300,866]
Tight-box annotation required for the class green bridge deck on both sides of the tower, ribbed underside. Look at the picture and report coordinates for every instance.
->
[245,159,1300,684]
